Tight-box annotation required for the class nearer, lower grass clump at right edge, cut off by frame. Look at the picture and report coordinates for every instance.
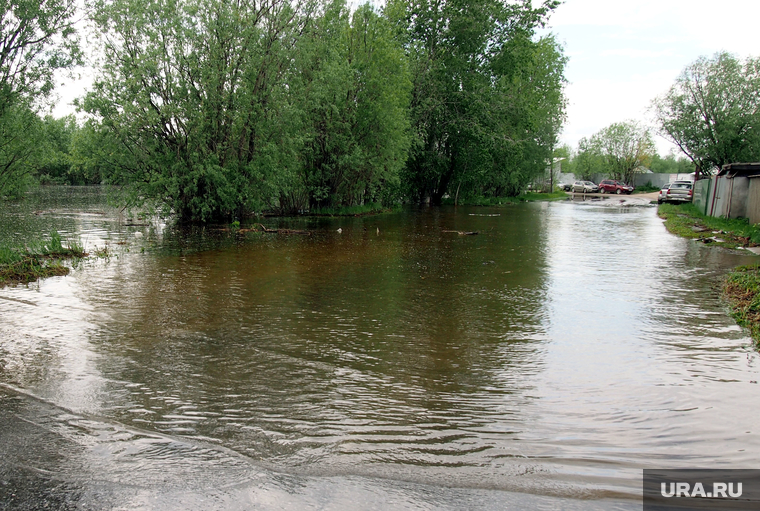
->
[723,265,760,348]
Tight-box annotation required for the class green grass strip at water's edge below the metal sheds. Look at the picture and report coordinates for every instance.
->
[657,203,760,248]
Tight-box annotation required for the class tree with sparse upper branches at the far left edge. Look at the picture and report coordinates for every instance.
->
[0,0,81,195]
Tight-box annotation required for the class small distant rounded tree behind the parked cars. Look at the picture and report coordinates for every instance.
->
[588,121,656,183]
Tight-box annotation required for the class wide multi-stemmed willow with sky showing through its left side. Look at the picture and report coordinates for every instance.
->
[83,0,311,221]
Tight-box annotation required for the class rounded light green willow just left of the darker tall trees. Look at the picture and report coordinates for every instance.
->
[282,0,411,209]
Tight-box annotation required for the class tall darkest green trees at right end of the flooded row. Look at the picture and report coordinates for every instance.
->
[385,0,565,203]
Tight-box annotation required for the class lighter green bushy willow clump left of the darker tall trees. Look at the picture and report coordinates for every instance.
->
[80,0,410,221]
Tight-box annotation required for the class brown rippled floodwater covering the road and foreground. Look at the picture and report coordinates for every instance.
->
[0,188,760,510]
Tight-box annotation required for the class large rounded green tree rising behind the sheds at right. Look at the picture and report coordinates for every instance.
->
[653,52,760,176]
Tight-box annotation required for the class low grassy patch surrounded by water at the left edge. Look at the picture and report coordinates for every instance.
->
[0,231,87,286]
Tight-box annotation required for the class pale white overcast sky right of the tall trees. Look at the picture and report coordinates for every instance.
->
[534,0,760,156]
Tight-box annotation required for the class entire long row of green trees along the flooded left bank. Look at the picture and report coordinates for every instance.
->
[0,0,570,217]
